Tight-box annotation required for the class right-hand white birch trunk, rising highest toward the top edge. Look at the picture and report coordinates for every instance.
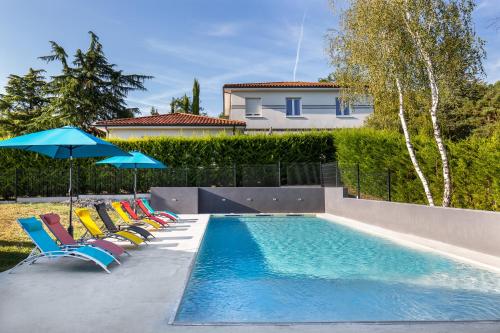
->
[405,5,451,207]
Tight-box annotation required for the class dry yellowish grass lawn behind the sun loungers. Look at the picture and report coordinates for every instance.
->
[0,203,110,272]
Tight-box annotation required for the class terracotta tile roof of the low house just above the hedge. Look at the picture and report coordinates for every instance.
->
[95,113,246,127]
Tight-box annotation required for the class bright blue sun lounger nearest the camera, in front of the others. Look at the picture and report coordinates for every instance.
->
[10,217,120,273]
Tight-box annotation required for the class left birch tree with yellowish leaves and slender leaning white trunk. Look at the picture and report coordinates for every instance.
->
[329,0,434,206]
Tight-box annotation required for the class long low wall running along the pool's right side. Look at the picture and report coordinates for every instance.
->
[325,188,500,256]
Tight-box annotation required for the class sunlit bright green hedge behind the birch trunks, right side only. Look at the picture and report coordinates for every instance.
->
[334,129,500,210]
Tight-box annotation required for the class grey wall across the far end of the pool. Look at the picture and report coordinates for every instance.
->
[151,187,325,214]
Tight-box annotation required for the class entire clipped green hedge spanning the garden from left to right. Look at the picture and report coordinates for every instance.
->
[0,129,500,210]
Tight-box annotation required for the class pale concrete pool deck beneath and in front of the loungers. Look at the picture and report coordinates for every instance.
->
[0,215,500,333]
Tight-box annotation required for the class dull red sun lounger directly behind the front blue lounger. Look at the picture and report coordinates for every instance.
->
[40,214,128,257]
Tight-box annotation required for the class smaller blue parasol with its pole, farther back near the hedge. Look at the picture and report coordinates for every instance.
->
[96,151,166,207]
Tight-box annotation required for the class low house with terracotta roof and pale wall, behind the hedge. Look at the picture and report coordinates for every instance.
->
[95,113,245,139]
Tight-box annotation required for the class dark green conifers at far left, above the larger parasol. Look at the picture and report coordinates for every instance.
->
[0,32,151,135]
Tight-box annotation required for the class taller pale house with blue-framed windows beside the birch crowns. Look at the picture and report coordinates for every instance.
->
[223,82,373,133]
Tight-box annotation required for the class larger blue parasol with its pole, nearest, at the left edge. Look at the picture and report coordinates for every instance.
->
[0,126,129,235]
